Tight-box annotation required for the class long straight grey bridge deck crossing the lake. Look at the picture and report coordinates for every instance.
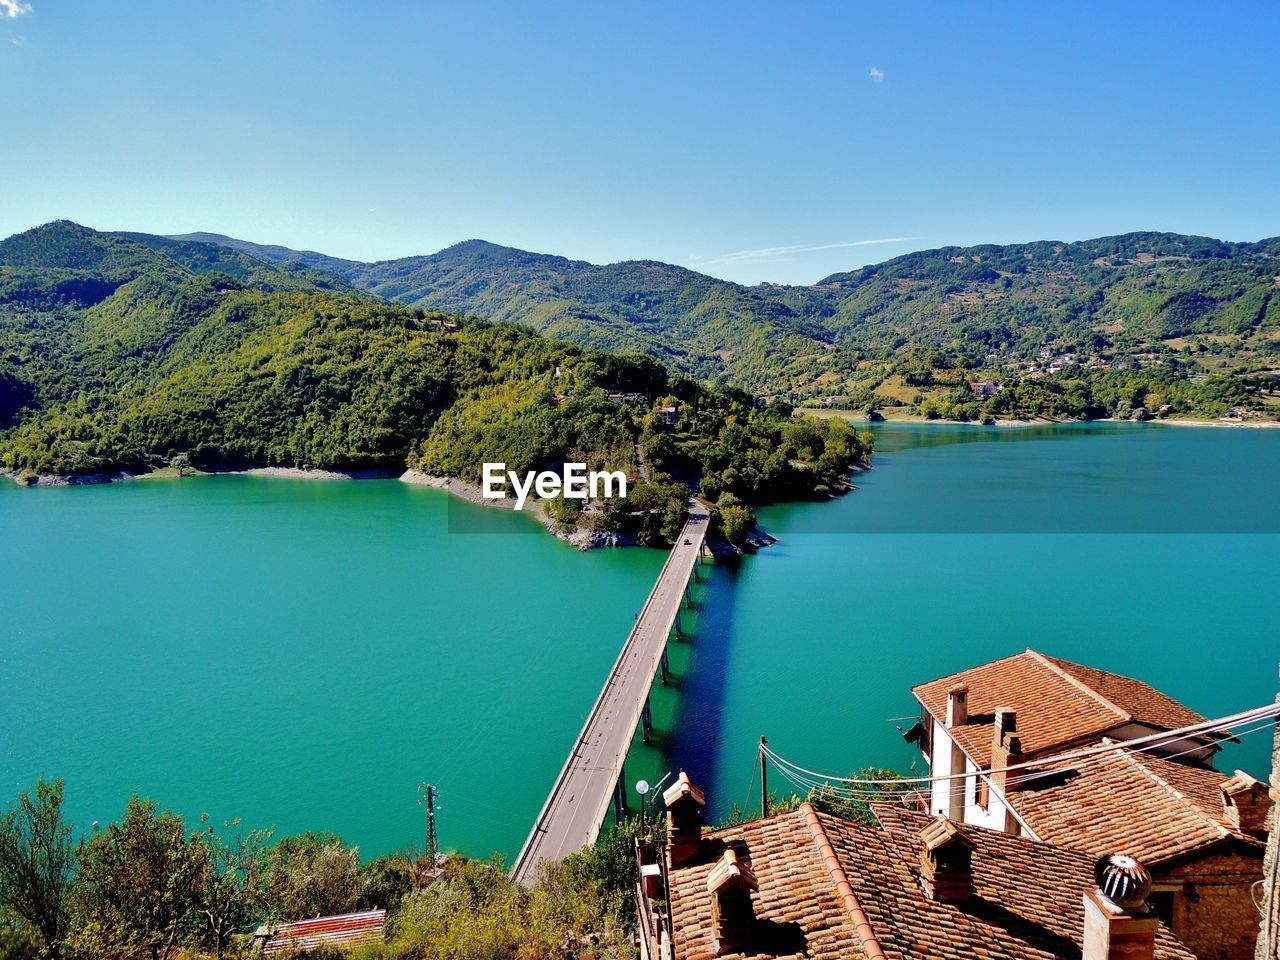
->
[512,502,708,883]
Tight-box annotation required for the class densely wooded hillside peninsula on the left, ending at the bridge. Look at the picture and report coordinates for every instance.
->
[0,223,869,541]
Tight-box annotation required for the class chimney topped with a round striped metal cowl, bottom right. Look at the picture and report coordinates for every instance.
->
[1080,854,1160,960]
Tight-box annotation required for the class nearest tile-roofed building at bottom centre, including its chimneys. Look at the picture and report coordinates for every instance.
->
[637,777,1193,960]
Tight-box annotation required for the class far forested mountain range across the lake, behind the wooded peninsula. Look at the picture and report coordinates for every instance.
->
[185,233,1280,416]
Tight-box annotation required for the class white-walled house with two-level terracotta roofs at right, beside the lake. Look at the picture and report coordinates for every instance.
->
[909,650,1270,960]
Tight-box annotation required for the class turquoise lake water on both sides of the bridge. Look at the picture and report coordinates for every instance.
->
[0,424,1280,856]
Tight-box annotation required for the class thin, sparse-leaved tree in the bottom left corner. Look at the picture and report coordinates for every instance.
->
[0,780,76,957]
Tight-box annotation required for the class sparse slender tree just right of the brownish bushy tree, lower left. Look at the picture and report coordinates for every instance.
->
[198,815,271,956]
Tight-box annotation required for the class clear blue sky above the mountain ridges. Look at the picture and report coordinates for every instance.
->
[0,0,1280,283]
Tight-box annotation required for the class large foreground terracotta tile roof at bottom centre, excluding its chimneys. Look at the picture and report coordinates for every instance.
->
[671,804,1192,960]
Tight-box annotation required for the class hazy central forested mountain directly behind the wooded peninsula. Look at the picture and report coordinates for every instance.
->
[172,234,854,393]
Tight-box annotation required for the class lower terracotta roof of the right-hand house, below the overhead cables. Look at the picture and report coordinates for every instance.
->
[1009,751,1262,868]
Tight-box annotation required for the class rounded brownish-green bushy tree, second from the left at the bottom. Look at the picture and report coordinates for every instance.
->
[70,795,206,960]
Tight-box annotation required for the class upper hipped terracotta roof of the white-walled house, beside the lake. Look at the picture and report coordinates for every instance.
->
[913,650,1204,767]
